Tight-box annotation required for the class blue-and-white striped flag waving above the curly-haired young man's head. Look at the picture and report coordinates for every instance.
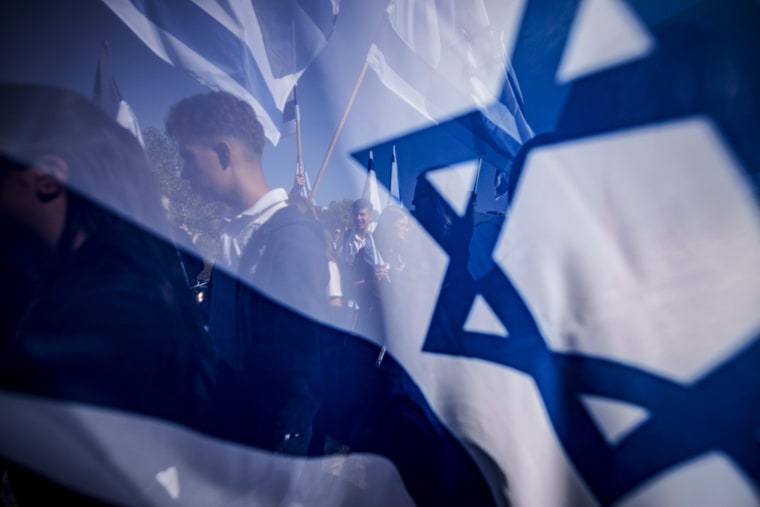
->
[103,0,338,144]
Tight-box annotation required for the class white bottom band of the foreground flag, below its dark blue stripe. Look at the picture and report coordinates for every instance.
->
[0,390,414,507]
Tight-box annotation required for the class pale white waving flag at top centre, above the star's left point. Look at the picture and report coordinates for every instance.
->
[367,0,532,149]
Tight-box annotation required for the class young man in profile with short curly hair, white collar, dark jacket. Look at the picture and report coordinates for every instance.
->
[166,92,328,454]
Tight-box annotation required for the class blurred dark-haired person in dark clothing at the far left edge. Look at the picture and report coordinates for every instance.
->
[0,85,223,505]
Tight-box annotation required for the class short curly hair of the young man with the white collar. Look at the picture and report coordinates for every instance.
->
[166,92,264,156]
